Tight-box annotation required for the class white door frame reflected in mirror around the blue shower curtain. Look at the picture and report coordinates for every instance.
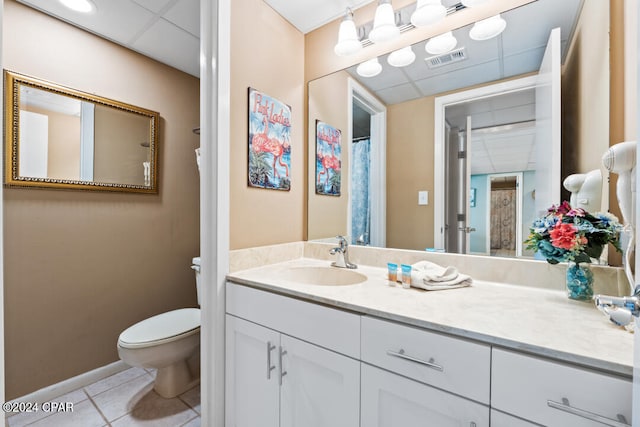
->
[346,77,387,247]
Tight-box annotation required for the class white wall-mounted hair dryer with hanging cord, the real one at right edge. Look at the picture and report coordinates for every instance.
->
[602,141,637,293]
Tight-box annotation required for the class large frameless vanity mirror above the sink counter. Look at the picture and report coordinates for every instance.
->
[308,0,610,258]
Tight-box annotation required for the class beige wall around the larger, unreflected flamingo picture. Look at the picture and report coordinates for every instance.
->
[229,0,306,249]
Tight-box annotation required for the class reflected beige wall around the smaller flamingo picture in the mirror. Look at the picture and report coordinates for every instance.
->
[307,71,351,240]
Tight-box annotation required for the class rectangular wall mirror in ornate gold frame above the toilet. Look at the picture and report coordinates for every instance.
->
[4,70,160,193]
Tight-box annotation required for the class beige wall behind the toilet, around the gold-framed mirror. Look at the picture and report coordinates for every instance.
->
[2,0,199,399]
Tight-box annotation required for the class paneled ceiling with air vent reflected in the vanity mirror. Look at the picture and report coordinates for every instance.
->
[347,0,582,104]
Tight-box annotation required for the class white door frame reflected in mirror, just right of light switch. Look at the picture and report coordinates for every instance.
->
[433,76,538,249]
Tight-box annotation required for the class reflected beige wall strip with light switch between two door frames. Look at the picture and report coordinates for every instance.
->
[387,96,435,250]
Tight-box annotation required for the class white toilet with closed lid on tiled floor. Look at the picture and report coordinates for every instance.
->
[118,258,200,398]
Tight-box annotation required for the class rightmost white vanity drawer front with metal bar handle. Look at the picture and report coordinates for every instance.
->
[491,349,632,427]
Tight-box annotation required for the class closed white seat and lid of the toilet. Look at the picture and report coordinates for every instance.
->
[118,308,200,348]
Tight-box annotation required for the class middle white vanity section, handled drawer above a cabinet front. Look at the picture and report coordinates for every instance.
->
[361,316,491,427]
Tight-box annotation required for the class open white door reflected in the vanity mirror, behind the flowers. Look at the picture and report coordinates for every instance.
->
[535,28,561,213]
